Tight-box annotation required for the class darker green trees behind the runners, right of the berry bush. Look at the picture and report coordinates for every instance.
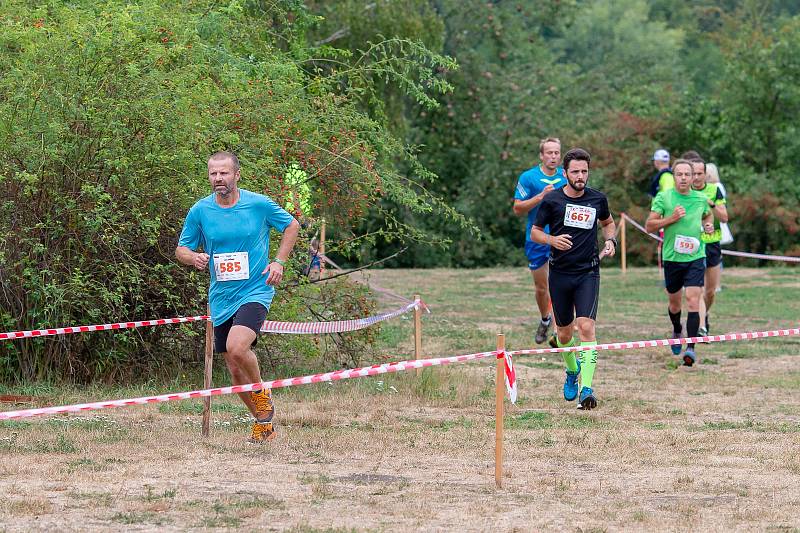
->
[315,0,800,267]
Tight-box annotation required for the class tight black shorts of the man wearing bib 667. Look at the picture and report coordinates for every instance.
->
[549,268,600,327]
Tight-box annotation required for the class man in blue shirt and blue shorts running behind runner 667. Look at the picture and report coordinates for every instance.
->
[514,137,567,344]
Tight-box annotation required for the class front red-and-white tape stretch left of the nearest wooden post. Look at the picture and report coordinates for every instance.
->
[0,352,497,420]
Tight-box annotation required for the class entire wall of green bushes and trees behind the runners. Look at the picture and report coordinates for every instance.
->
[0,0,800,382]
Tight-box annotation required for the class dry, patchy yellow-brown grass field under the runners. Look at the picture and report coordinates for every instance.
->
[0,268,800,532]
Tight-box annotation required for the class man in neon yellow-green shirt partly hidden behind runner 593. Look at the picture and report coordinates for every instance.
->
[692,158,728,337]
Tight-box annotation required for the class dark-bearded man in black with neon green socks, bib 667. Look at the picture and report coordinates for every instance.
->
[531,148,617,409]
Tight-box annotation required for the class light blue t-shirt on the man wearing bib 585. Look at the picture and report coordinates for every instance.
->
[178,189,294,326]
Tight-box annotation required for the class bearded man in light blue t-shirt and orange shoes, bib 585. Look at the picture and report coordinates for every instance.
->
[175,152,300,442]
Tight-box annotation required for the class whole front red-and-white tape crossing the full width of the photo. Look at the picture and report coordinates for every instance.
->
[0,328,800,420]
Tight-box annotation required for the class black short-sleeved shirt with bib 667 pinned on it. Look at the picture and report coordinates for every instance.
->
[536,187,611,272]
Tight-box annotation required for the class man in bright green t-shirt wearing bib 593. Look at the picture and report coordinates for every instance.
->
[645,159,714,366]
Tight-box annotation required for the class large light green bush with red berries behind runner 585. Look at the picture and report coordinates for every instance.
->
[0,0,462,382]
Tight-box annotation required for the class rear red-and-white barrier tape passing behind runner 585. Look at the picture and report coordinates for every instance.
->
[0,300,430,340]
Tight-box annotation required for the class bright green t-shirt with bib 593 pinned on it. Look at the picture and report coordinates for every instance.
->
[650,189,711,263]
